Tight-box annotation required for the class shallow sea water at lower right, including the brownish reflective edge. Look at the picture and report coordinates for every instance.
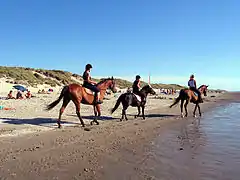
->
[146,103,240,180]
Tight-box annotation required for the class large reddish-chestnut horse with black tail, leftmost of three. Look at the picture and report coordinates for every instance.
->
[46,77,116,128]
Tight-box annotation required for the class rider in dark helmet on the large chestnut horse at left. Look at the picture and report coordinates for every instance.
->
[83,64,102,104]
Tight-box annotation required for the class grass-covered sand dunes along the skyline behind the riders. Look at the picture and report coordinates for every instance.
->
[0,66,184,89]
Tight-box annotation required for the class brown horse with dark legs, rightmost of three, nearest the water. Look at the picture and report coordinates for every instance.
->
[170,85,208,117]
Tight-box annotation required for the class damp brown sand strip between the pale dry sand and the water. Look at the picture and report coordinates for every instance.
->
[0,93,236,179]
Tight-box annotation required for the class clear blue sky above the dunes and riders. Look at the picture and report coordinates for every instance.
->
[0,0,240,90]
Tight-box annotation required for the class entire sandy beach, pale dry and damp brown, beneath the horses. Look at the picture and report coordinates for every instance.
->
[0,90,231,180]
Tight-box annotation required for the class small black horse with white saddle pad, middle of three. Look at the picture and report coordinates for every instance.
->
[111,85,156,121]
